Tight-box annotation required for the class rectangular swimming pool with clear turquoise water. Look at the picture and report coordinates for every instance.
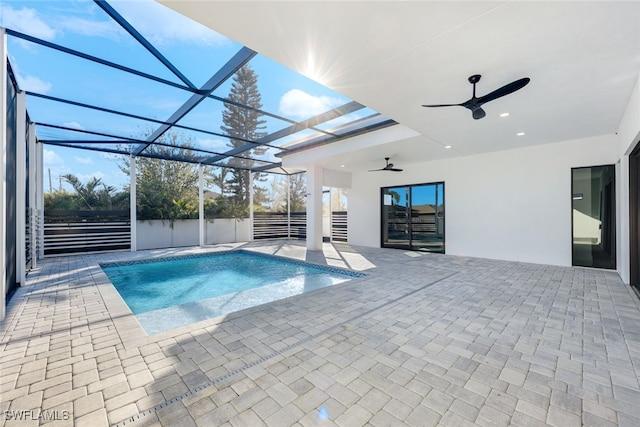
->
[100,250,364,333]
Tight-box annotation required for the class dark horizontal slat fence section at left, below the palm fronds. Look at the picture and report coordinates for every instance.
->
[44,211,131,256]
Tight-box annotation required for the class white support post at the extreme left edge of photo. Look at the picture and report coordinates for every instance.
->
[0,27,7,320]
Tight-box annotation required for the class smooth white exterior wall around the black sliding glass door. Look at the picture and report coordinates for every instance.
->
[349,135,618,265]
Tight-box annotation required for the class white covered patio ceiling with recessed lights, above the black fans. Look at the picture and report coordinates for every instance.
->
[164,0,640,172]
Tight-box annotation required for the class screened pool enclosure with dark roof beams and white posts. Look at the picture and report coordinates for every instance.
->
[0,0,396,320]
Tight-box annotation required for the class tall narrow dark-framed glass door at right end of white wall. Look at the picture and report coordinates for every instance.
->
[571,165,616,269]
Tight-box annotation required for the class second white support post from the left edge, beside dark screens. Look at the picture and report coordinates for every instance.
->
[16,91,27,286]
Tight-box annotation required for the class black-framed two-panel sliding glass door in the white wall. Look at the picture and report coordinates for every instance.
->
[381,182,444,253]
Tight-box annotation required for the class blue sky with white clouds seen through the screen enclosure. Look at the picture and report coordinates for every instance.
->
[0,0,366,191]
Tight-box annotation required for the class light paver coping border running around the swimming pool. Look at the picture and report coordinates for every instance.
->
[95,248,369,349]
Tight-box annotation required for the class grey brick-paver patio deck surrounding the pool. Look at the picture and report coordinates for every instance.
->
[0,241,640,427]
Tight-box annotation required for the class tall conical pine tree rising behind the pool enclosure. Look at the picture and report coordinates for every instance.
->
[220,65,267,214]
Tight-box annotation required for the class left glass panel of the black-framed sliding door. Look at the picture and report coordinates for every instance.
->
[382,187,410,247]
